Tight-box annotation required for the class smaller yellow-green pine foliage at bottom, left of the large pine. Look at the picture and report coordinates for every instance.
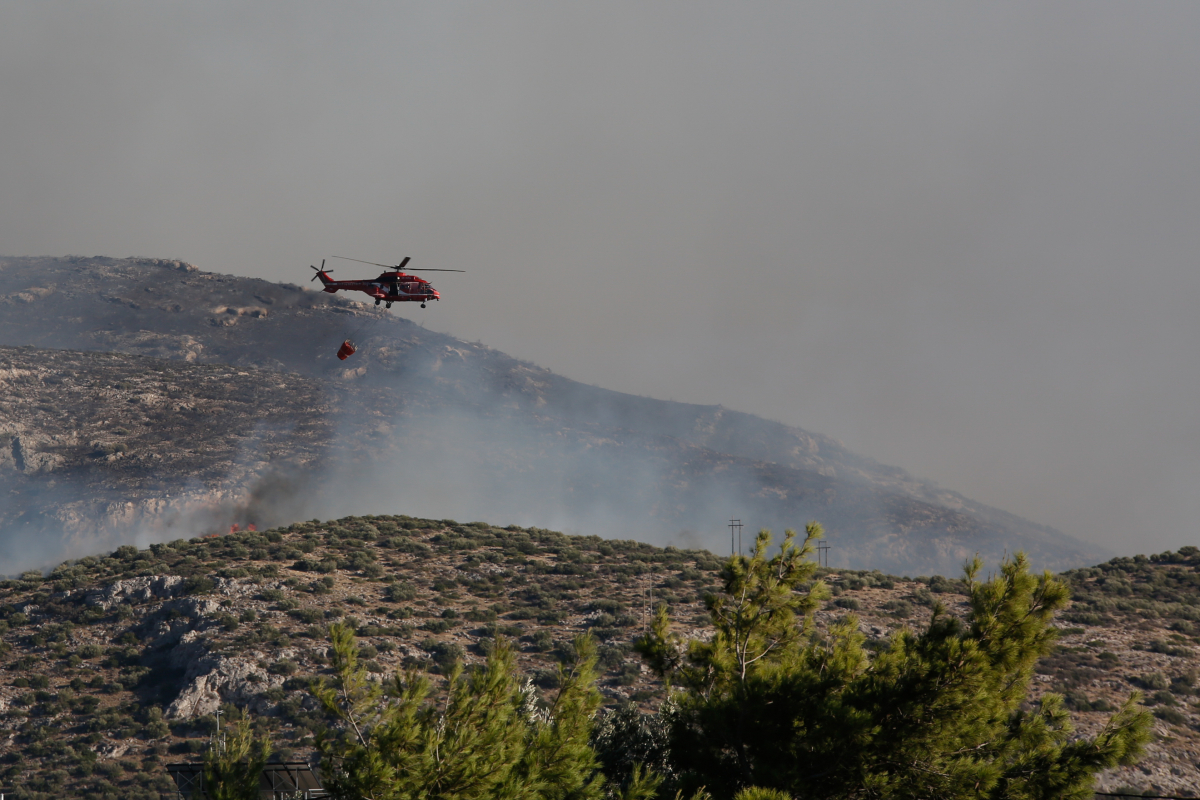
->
[313,624,609,800]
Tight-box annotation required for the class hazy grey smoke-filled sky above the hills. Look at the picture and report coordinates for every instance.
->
[0,0,1200,553]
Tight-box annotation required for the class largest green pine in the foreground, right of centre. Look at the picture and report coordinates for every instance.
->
[638,523,1151,800]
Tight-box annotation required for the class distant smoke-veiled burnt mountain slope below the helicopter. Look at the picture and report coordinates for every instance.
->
[0,258,1103,572]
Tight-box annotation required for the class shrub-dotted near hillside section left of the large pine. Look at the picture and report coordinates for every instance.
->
[0,517,719,798]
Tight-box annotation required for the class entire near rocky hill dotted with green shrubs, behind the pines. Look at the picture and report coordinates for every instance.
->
[0,517,1200,799]
